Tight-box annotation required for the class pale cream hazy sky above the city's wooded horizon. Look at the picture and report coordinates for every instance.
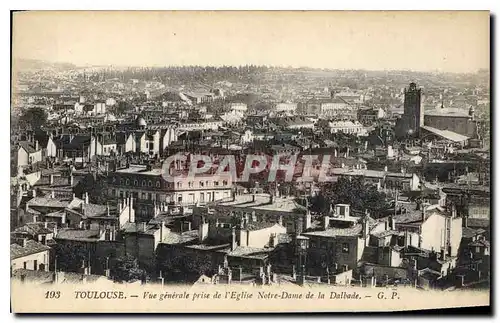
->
[13,11,490,72]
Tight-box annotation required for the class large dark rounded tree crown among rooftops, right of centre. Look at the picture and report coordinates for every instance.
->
[311,177,389,219]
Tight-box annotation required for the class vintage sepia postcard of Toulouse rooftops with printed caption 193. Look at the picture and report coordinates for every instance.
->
[10,11,491,313]
